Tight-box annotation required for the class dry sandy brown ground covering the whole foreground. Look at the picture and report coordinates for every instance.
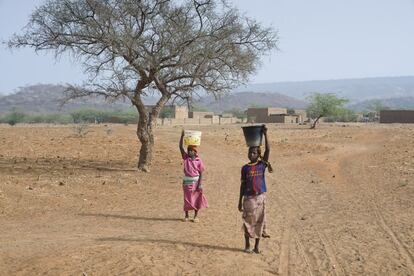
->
[0,124,414,275]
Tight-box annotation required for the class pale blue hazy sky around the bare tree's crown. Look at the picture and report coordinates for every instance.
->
[0,0,414,94]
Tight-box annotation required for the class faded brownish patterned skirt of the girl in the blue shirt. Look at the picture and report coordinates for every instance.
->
[242,194,266,239]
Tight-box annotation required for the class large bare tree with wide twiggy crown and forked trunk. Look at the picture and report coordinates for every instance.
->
[8,0,277,171]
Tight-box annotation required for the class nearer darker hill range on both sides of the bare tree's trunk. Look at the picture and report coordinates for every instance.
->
[0,84,306,113]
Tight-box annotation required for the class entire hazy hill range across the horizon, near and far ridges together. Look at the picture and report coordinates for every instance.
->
[0,77,414,113]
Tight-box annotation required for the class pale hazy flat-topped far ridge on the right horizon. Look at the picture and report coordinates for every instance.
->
[235,76,414,102]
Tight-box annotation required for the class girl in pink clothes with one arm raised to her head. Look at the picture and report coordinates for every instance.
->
[179,130,208,222]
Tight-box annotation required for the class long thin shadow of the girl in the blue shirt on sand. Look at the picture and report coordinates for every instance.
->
[96,237,243,252]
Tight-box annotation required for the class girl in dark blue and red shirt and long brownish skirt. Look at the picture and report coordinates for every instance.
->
[238,125,273,254]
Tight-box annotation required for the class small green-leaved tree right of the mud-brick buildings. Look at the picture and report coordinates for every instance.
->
[306,93,348,129]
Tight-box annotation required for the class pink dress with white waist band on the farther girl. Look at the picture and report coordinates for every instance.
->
[183,154,208,211]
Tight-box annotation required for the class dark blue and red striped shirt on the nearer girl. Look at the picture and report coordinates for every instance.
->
[241,161,267,196]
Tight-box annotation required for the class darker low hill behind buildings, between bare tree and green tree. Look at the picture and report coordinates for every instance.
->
[195,92,306,112]
